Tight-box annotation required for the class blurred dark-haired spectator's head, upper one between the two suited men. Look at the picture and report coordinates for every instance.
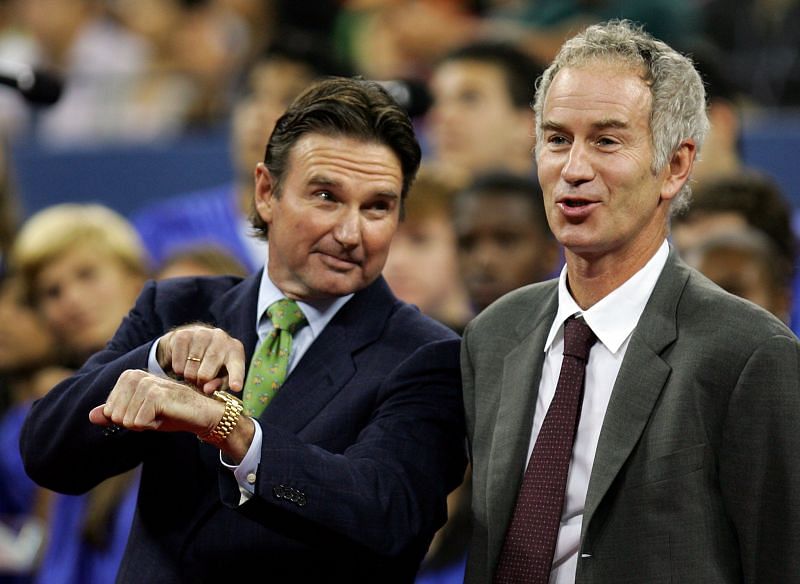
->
[426,43,542,185]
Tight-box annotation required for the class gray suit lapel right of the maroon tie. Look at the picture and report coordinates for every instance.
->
[583,249,689,534]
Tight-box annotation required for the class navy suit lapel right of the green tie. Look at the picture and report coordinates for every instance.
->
[261,278,397,433]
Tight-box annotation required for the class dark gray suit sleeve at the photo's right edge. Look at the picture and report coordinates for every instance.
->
[719,336,800,583]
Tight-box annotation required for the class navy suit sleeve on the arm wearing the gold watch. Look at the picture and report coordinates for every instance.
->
[220,339,466,556]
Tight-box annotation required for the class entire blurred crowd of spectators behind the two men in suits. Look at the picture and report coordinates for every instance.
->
[0,0,800,584]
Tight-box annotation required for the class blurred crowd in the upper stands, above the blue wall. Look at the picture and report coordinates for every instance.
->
[0,0,800,145]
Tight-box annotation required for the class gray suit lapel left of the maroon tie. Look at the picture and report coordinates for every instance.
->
[487,283,558,562]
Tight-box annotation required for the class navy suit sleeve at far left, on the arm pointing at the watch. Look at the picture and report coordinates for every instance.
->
[20,282,162,494]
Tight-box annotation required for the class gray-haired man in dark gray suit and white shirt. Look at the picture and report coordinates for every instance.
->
[462,21,800,584]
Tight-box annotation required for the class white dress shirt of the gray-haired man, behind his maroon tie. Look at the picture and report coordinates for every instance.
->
[528,240,669,584]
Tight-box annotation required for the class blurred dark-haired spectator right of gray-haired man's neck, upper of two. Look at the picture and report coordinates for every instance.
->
[671,173,800,329]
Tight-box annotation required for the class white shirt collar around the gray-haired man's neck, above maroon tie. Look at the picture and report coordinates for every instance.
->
[544,240,669,353]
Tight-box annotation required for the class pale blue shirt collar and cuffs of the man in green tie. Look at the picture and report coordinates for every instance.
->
[148,248,353,504]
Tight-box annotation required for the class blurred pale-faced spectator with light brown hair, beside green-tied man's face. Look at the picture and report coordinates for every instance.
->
[383,173,472,332]
